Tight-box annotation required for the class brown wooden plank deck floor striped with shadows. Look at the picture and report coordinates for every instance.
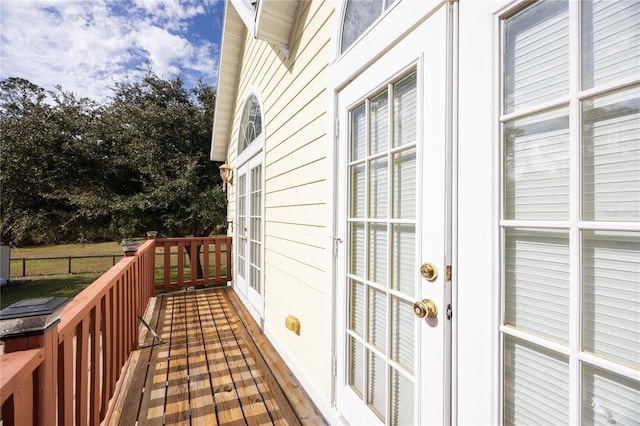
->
[110,287,326,425]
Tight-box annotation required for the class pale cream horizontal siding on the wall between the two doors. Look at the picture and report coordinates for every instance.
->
[228,2,335,395]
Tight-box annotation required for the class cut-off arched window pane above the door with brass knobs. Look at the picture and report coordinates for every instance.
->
[340,0,395,52]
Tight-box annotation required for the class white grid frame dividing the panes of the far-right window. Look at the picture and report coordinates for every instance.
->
[495,1,640,424]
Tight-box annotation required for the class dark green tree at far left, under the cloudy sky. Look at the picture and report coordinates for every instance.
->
[0,78,110,244]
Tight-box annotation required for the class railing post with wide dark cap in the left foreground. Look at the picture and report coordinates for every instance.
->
[0,297,71,426]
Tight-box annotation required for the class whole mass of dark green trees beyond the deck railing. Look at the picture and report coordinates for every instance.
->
[0,72,226,245]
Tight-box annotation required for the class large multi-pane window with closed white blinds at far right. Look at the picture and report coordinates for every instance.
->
[500,0,640,424]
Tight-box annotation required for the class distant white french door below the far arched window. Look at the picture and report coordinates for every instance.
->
[236,154,264,317]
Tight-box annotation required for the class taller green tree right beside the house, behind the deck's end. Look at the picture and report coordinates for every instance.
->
[103,73,226,240]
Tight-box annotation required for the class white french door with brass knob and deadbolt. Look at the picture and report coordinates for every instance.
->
[336,7,451,425]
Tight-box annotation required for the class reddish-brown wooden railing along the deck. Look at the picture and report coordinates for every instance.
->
[0,237,231,426]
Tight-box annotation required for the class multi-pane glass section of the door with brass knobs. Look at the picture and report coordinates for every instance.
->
[345,73,418,424]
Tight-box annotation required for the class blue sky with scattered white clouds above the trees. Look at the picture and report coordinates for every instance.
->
[0,0,224,101]
